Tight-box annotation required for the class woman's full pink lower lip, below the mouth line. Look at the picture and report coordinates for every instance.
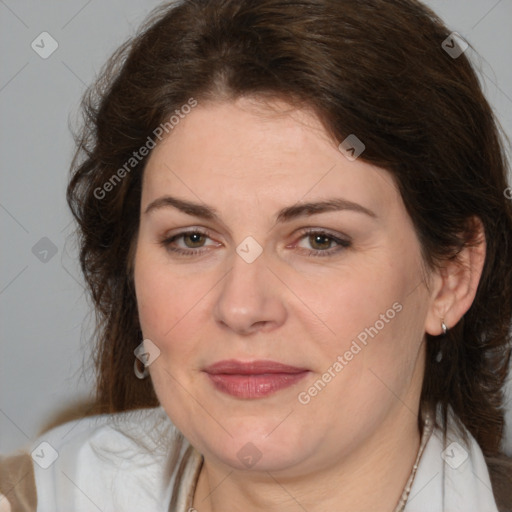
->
[207,371,309,398]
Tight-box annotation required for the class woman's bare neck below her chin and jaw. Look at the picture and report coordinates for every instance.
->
[193,406,420,512]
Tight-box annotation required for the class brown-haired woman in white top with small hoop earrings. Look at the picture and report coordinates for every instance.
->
[2,0,512,512]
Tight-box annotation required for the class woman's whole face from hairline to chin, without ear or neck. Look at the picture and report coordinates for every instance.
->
[134,99,432,472]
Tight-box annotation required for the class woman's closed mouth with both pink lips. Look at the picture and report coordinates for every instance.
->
[203,359,309,399]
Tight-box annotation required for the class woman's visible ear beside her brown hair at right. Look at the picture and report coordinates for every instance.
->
[425,217,487,336]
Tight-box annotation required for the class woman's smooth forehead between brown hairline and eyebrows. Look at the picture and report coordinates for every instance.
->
[143,99,397,214]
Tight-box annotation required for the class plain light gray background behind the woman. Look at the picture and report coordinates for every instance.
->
[0,0,512,453]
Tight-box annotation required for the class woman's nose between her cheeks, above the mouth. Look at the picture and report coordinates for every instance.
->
[214,248,287,335]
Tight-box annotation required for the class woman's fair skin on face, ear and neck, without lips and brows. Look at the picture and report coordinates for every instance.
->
[134,98,485,512]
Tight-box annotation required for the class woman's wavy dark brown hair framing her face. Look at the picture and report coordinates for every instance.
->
[67,0,512,464]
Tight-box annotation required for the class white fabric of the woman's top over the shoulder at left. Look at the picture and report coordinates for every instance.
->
[0,407,188,512]
